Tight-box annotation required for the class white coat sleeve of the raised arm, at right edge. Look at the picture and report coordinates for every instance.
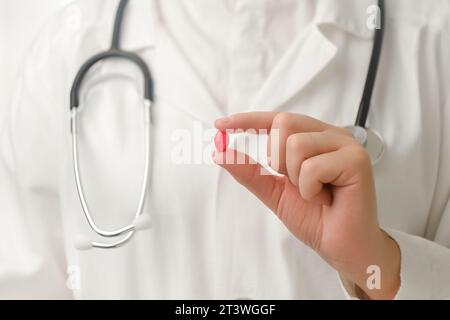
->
[386,73,450,299]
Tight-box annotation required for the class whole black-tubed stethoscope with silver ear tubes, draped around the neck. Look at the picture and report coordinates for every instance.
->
[70,0,385,250]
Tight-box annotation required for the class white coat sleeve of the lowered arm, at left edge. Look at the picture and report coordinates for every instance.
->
[0,17,72,299]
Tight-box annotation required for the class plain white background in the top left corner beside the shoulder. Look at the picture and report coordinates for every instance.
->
[0,0,70,131]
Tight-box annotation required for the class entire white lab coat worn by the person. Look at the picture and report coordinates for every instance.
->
[0,0,450,299]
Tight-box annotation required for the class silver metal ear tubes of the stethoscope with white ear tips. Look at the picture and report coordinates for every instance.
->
[70,100,152,250]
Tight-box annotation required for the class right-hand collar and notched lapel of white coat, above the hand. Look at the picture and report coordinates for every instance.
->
[250,0,377,111]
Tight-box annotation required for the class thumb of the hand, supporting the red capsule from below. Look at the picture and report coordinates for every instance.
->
[213,149,285,212]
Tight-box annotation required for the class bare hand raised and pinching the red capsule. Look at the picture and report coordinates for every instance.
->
[213,112,400,299]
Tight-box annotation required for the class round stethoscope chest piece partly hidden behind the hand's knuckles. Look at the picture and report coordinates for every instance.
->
[347,126,385,166]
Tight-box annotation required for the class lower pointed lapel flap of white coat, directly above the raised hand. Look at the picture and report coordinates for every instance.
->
[251,24,337,111]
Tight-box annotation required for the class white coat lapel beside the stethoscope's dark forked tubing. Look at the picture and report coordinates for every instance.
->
[118,0,225,126]
